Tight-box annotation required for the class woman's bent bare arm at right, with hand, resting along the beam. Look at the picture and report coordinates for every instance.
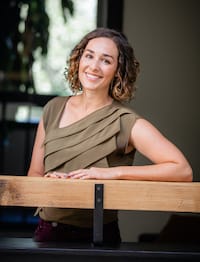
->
[65,119,192,181]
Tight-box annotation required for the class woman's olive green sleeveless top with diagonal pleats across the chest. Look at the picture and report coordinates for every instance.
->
[38,97,139,227]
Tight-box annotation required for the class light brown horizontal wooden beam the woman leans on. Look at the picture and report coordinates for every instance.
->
[0,175,200,212]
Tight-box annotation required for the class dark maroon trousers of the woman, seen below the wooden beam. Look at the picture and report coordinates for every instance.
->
[34,219,121,244]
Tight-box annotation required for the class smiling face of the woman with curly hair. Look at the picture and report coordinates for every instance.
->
[79,37,119,92]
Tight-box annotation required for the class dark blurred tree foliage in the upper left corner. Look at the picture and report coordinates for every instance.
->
[0,0,74,91]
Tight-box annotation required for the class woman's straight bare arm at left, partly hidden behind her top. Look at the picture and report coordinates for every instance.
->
[28,120,45,176]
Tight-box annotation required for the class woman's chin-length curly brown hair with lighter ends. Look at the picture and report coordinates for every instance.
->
[65,28,139,101]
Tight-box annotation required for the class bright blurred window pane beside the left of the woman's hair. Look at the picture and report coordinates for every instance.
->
[32,0,97,95]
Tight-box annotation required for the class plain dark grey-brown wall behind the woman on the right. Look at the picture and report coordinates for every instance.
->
[120,0,200,241]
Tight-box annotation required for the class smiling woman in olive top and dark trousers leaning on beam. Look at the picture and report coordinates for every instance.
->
[28,28,192,243]
